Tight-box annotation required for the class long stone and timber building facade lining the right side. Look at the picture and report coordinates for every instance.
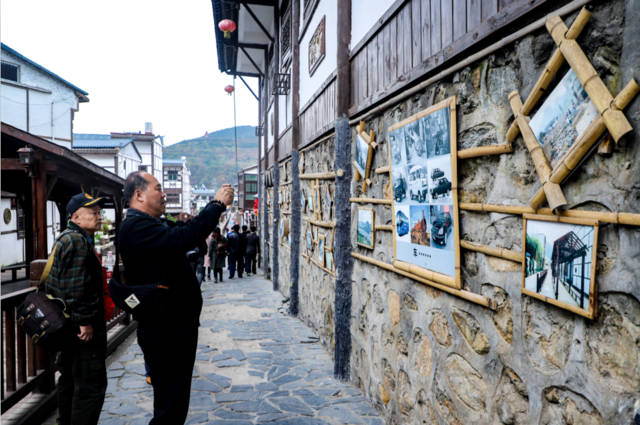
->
[212,0,640,424]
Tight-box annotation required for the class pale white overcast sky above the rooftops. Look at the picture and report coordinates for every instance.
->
[0,0,258,145]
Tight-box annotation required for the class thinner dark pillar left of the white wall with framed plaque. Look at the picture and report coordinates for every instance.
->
[289,0,302,316]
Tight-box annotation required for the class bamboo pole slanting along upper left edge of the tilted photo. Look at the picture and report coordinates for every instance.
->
[507,7,591,142]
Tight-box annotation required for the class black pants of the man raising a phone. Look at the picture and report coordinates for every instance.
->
[138,321,198,425]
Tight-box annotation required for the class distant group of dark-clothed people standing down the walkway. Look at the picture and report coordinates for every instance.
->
[204,224,260,283]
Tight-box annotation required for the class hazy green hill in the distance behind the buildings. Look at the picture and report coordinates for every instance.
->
[163,125,258,188]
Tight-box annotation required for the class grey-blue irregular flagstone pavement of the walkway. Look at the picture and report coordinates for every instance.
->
[47,276,384,425]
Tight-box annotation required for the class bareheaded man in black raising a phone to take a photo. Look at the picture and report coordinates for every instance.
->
[118,171,233,425]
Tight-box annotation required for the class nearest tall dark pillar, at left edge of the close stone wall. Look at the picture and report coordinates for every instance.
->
[333,0,353,380]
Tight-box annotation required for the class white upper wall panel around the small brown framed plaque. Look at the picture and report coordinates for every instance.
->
[300,0,338,108]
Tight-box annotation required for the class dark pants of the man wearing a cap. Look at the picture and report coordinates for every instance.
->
[58,342,107,425]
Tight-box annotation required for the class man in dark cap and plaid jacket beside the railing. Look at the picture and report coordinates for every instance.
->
[44,193,107,425]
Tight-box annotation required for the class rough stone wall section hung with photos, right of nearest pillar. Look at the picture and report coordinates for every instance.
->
[351,0,640,424]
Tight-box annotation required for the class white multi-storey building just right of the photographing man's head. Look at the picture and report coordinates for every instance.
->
[162,156,192,214]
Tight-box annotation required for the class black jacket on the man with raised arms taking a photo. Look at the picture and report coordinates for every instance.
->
[117,203,226,325]
